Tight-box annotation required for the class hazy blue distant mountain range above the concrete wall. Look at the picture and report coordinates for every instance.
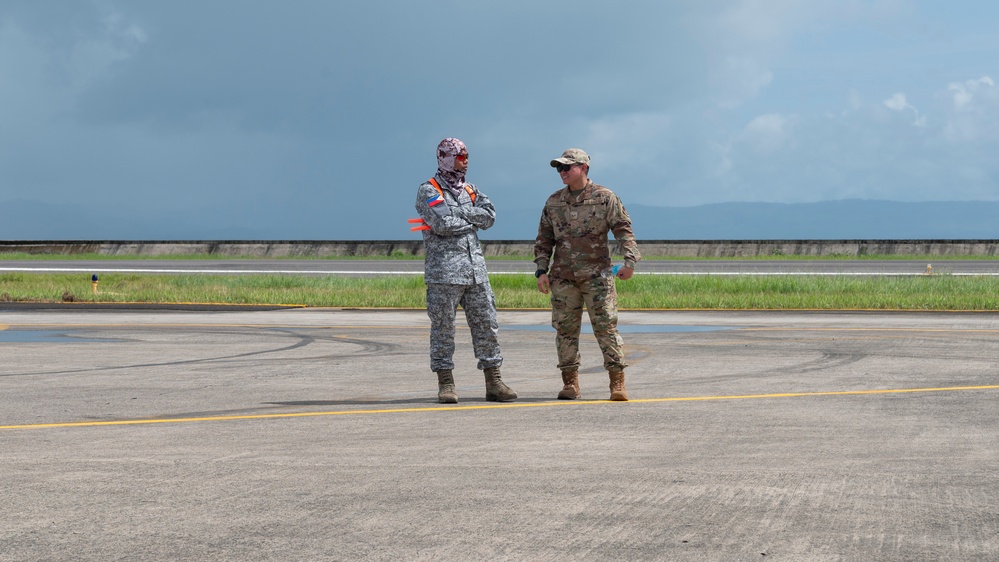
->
[0,199,999,240]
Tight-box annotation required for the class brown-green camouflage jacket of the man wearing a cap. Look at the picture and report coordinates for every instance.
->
[534,181,641,281]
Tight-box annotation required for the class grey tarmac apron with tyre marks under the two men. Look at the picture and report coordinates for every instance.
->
[0,305,999,561]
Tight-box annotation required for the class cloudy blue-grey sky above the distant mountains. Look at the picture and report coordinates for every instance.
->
[0,0,999,240]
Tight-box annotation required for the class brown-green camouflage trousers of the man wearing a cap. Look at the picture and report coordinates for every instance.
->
[551,277,628,371]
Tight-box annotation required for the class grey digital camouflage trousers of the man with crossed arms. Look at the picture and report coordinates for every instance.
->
[427,281,503,372]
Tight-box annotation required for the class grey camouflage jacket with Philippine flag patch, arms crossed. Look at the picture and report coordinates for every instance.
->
[416,176,496,285]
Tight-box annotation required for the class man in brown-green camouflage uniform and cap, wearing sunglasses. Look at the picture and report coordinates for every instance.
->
[534,148,641,400]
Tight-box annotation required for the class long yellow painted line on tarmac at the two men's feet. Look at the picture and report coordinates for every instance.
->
[0,385,999,430]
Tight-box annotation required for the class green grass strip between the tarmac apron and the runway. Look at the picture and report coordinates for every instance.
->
[0,273,999,310]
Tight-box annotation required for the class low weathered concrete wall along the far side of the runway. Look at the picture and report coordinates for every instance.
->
[0,240,999,258]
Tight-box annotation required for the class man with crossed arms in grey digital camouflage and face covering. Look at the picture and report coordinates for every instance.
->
[416,138,517,404]
